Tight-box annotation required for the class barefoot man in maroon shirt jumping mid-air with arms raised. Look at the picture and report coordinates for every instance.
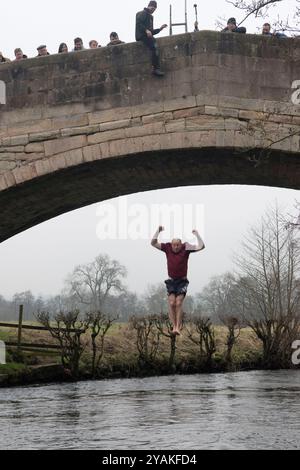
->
[151,226,205,335]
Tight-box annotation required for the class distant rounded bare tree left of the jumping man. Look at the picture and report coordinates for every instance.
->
[67,255,127,311]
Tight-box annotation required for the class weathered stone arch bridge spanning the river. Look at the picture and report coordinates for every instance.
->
[0,31,300,241]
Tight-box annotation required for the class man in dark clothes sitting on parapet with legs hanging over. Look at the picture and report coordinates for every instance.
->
[135,1,167,77]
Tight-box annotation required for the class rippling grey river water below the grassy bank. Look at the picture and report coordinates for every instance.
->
[0,371,300,450]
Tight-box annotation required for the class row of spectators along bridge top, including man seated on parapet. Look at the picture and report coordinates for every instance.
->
[0,1,287,76]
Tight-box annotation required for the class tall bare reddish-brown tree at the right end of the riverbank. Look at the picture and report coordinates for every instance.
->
[235,207,300,367]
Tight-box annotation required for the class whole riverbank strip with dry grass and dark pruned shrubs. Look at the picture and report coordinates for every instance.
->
[0,312,298,386]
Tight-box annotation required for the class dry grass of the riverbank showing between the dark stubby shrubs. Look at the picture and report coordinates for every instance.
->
[0,324,268,387]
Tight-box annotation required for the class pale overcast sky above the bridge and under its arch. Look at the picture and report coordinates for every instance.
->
[0,0,299,297]
